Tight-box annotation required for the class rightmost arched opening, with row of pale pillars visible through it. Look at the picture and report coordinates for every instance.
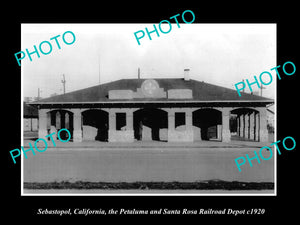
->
[230,108,260,141]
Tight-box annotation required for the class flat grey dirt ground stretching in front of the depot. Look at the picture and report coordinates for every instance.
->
[23,147,274,182]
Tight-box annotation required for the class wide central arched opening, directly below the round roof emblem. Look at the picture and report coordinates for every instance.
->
[133,108,168,141]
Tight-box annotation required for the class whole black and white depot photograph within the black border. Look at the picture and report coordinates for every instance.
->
[19,23,276,195]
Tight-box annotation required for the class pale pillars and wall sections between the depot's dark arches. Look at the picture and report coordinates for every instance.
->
[39,107,268,142]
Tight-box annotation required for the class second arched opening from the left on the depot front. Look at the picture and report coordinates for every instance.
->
[82,109,108,142]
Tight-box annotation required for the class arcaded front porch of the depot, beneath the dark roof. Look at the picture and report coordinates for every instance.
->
[38,102,268,142]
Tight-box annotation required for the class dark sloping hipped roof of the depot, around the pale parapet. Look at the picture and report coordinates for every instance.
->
[32,78,273,104]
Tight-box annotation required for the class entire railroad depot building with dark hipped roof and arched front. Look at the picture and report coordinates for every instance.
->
[30,70,274,142]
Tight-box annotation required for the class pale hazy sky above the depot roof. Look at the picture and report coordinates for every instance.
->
[21,22,277,98]
